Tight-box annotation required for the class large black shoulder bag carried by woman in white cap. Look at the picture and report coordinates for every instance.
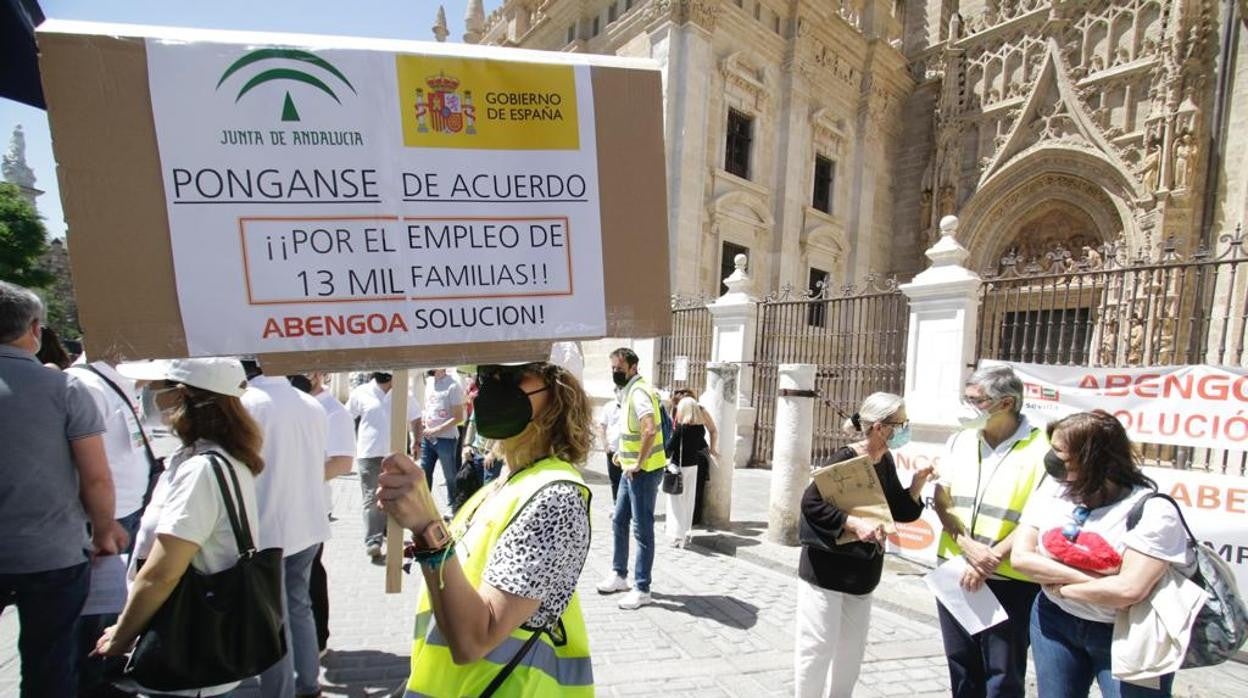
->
[125,451,286,691]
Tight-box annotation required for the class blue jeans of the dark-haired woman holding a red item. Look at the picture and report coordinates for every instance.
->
[1031,594,1174,698]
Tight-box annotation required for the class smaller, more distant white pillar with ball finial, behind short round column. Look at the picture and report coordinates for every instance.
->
[708,255,759,468]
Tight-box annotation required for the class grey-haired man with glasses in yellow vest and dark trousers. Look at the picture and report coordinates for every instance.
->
[935,366,1048,698]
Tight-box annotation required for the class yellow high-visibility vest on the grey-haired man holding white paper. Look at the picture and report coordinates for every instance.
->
[936,427,1050,582]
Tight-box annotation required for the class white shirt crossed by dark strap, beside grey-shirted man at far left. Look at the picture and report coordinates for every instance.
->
[71,361,151,518]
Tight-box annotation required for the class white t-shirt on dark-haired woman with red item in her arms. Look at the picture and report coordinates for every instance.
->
[1018,478,1193,623]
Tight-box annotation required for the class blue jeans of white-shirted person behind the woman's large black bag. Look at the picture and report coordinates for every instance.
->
[260,543,321,698]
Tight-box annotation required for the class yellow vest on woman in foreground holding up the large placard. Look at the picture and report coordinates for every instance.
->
[404,457,594,698]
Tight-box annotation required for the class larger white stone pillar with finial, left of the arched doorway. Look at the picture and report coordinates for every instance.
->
[901,216,981,442]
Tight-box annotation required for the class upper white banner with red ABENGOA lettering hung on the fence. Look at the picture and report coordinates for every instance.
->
[980,361,1248,451]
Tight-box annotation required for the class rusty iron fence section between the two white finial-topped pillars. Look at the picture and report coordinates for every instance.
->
[750,275,909,465]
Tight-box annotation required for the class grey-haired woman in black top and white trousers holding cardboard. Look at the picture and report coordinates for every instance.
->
[794,392,934,698]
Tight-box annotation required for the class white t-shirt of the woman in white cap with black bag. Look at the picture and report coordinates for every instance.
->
[130,441,261,696]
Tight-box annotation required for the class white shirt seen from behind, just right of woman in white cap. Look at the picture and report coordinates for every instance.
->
[242,376,329,556]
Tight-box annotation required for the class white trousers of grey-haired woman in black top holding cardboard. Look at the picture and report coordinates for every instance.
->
[794,579,871,698]
